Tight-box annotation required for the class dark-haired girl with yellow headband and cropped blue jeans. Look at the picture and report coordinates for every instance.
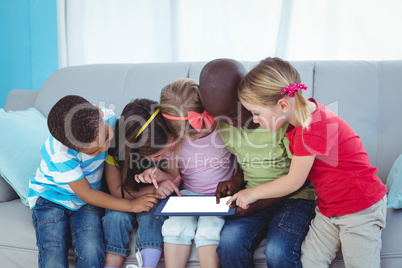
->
[103,99,180,267]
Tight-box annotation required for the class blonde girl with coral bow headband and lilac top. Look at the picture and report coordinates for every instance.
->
[138,79,236,268]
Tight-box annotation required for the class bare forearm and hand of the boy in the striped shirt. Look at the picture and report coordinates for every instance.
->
[68,177,160,213]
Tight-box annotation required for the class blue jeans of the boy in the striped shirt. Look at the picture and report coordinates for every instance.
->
[32,198,105,268]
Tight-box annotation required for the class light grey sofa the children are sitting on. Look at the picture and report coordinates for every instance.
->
[0,61,402,268]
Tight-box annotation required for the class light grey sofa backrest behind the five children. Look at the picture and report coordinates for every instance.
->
[6,61,402,182]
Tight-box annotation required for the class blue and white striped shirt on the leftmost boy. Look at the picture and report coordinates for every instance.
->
[28,108,116,211]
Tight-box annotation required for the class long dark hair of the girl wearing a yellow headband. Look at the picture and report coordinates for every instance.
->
[109,99,173,196]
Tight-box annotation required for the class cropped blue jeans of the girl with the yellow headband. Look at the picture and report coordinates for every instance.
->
[102,202,166,257]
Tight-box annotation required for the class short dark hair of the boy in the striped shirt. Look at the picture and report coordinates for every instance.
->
[47,95,102,151]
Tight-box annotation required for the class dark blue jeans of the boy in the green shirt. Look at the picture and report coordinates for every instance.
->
[216,199,315,268]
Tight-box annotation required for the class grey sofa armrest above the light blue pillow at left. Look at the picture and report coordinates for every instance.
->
[4,89,40,111]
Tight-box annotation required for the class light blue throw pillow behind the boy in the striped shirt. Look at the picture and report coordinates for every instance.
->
[0,108,49,205]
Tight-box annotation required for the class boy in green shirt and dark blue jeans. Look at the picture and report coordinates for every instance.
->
[200,59,315,268]
